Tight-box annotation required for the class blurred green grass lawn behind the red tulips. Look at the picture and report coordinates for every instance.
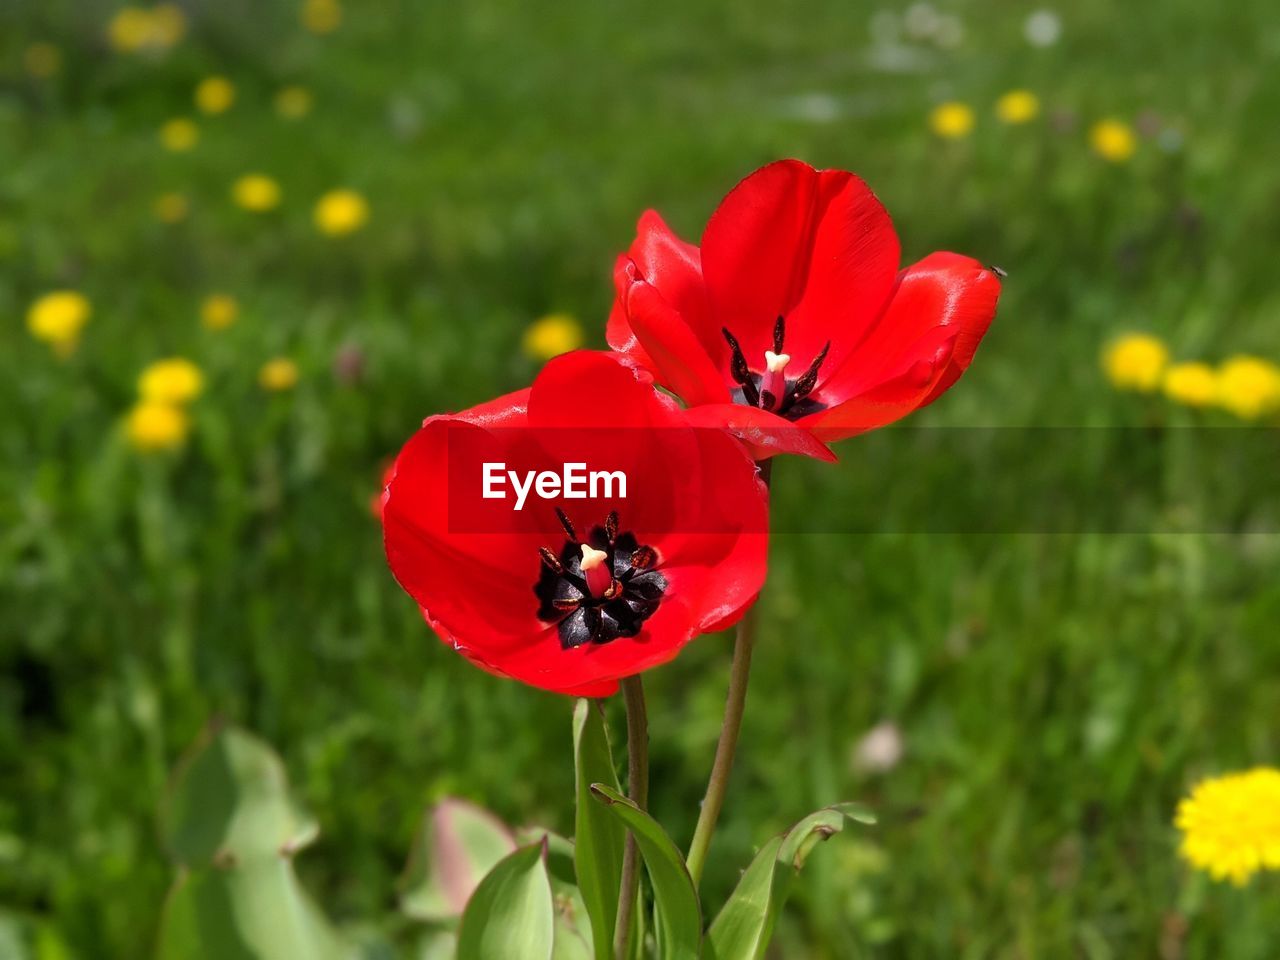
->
[0,0,1280,960]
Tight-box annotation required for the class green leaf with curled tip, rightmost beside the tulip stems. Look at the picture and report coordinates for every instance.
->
[707,804,876,960]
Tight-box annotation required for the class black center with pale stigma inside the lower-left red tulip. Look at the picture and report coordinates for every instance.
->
[534,509,667,650]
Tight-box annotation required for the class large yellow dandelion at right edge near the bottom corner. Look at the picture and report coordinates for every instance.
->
[1174,767,1280,887]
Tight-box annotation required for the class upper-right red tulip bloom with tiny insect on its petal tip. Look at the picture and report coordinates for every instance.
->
[608,160,1000,460]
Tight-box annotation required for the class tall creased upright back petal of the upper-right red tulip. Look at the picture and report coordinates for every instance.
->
[701,160,899,378]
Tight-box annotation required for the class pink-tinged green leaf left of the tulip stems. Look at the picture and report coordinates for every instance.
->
[399,797,516,923]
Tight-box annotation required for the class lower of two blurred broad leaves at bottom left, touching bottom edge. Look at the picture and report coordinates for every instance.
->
[157,856,353,960]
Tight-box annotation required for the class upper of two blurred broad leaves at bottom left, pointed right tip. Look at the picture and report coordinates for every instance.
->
[164,727,317,867]
